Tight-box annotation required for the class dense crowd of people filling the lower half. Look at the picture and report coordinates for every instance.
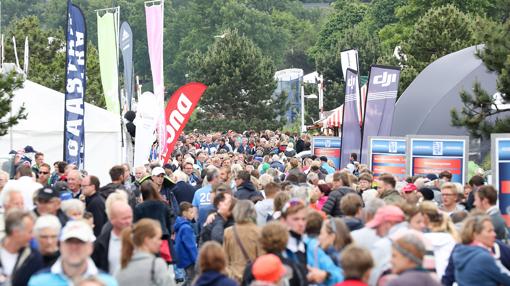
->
[0,131,510,286]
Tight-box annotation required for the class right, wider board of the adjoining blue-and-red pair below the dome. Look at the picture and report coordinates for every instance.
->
[407,135,469,185]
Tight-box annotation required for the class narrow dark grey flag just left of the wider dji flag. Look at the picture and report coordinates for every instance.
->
[340,68,361,168]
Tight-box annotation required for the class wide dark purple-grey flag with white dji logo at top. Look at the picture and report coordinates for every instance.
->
[361,65,400,164]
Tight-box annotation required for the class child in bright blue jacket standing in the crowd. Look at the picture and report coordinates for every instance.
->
[174,202,198,285]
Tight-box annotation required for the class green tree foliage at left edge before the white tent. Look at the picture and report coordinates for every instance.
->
[0,72,27,136]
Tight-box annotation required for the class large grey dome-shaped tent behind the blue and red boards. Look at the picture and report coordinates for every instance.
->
[391,45,497,136]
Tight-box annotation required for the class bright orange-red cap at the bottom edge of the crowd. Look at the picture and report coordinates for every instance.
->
[251,254,286,283]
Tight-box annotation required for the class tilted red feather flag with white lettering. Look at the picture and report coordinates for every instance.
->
[164,82,207,163]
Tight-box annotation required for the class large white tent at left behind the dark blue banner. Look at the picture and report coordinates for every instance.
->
[0,80,122,184]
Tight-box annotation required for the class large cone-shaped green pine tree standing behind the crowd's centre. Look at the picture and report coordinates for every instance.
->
[189,30,281,131]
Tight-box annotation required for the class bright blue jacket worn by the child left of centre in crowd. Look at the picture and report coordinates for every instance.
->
[174,216,198,268]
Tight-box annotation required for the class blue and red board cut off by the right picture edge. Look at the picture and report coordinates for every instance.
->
[491,133,510,226]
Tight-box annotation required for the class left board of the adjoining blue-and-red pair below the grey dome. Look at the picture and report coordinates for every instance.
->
[368,136,407,180]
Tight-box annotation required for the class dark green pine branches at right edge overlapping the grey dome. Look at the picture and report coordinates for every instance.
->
[451,20,510,138]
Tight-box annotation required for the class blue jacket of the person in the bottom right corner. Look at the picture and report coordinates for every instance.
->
[452,245,510,286]
